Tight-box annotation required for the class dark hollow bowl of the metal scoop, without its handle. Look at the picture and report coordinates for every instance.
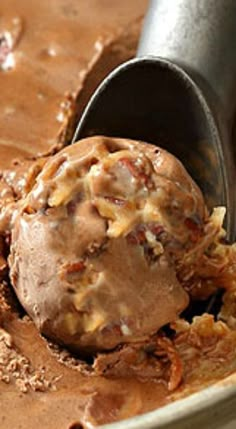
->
[75,58,232,230]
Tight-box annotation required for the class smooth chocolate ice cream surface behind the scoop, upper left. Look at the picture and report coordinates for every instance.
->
[0,0,147,168]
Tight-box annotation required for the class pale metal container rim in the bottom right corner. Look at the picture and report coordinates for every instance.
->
[102,378,236,429]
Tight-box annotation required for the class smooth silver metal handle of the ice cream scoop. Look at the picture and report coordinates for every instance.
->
[137,0,236,120]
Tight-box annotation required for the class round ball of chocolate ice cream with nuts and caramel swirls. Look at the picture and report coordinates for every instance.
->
[9,137,206,353]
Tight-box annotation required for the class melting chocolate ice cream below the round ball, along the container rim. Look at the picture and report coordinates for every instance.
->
[0,290,236,429]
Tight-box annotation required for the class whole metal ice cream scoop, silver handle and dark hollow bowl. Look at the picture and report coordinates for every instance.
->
[73,0,236,238]
